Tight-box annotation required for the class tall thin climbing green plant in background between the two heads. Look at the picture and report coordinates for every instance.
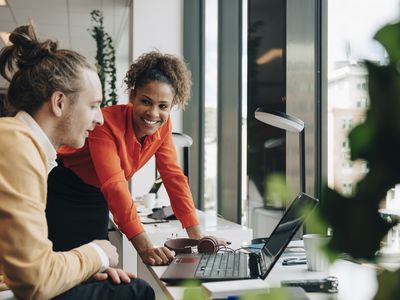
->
[89,9,118,107]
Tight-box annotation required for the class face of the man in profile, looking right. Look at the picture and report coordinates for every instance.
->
[59,69,104,148]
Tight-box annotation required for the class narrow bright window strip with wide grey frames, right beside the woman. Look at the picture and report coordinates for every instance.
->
[183,0,242,223]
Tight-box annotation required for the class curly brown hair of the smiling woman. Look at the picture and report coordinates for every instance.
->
[125,51,192,109]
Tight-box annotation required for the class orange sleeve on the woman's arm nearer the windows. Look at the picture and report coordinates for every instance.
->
[156,123,199,228]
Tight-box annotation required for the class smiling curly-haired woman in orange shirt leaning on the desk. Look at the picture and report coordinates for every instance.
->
[46,51,206,265]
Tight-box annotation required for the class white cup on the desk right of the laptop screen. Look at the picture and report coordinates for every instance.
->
[303,233,331,272]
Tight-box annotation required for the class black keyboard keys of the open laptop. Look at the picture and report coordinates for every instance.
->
[195,252,248,278]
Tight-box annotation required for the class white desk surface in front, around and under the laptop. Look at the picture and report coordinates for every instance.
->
[138,241,378,300]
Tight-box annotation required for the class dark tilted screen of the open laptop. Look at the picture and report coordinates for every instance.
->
[261,193,318,279]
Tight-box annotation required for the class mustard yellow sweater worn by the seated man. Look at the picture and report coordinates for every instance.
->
[0,118,101,299]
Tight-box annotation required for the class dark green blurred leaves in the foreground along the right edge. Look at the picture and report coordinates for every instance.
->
[319,23,400,300]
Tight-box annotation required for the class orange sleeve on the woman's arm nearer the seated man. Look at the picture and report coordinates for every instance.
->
[88,126,144,239]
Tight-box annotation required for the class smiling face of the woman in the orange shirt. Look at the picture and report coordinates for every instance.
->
[131,81,175,142]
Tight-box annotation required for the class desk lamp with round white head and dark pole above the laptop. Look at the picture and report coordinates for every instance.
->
[255,107,306,192]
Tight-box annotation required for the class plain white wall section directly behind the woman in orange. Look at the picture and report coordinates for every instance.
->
[132,0,184,197]
